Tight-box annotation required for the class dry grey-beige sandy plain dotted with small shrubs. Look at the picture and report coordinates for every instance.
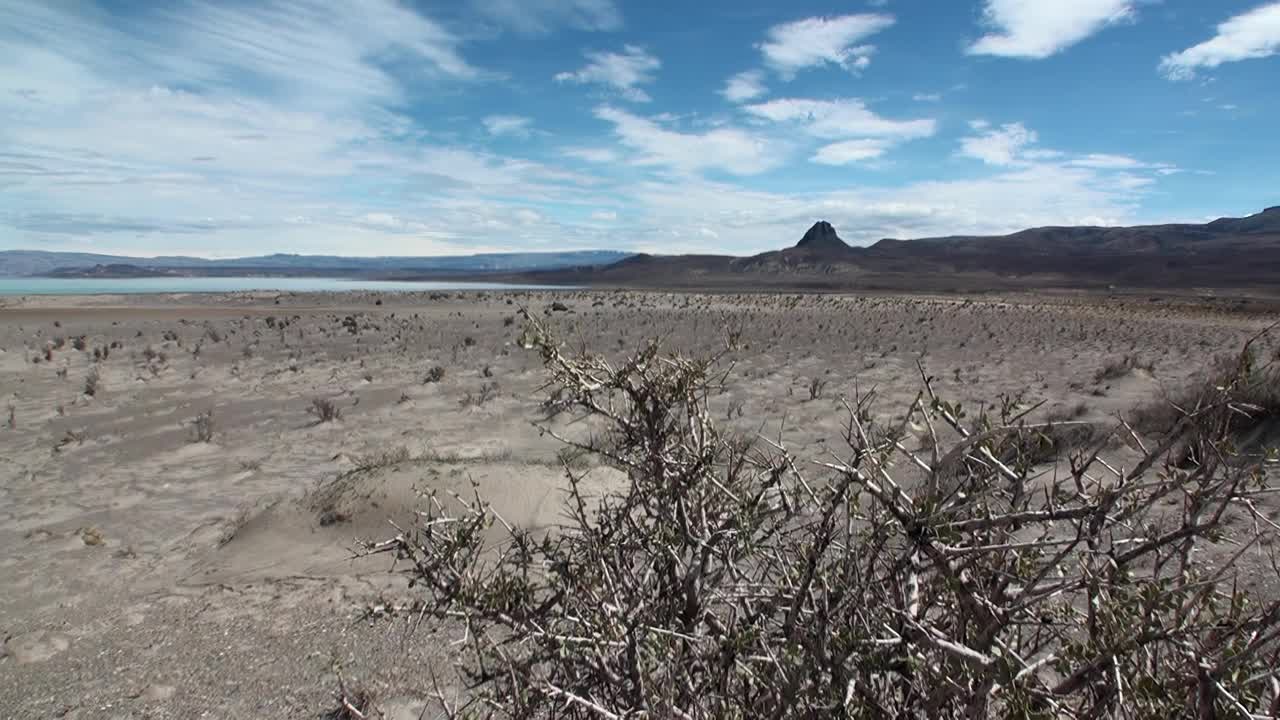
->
[0,291,1280,717]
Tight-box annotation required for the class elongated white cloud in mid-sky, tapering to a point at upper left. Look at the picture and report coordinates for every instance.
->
[595,106,783,176]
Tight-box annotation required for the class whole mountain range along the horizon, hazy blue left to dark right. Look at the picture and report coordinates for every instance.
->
[10,206,1280,292]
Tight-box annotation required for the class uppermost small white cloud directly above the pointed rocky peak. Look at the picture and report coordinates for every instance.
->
[759,13,893,78]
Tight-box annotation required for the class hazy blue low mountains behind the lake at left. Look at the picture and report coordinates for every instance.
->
[0,250,630,278]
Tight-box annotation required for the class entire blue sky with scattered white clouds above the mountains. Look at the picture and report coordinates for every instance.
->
[0,0,1280,258]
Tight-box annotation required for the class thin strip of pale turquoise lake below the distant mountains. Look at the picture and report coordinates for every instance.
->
[0,278,566,296]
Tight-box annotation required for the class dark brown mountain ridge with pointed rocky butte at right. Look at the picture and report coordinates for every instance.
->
[521,208,1280,291]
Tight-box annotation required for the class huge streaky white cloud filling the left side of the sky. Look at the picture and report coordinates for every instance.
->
[0,0,640,256]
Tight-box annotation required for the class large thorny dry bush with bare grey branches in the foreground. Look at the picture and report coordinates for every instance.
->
[366,320,1280,719]
